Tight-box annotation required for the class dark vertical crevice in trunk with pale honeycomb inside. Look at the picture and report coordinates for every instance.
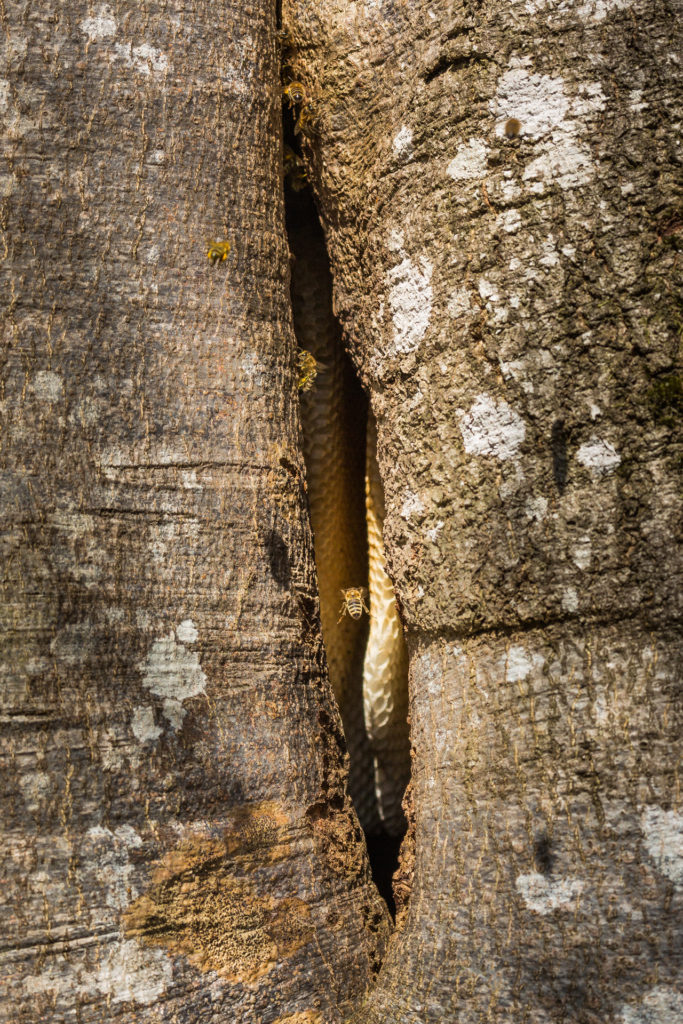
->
[286,148,410,912]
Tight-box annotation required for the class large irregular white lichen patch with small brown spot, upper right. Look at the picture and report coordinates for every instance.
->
[490,60,606,193]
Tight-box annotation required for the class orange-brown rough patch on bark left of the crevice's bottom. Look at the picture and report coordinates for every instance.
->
[124,805,313,983]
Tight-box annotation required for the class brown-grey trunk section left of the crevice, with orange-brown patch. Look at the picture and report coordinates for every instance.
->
[0,0,388,1024]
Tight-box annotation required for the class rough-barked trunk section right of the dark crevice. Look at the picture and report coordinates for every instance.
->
[285,0,683,1024]
